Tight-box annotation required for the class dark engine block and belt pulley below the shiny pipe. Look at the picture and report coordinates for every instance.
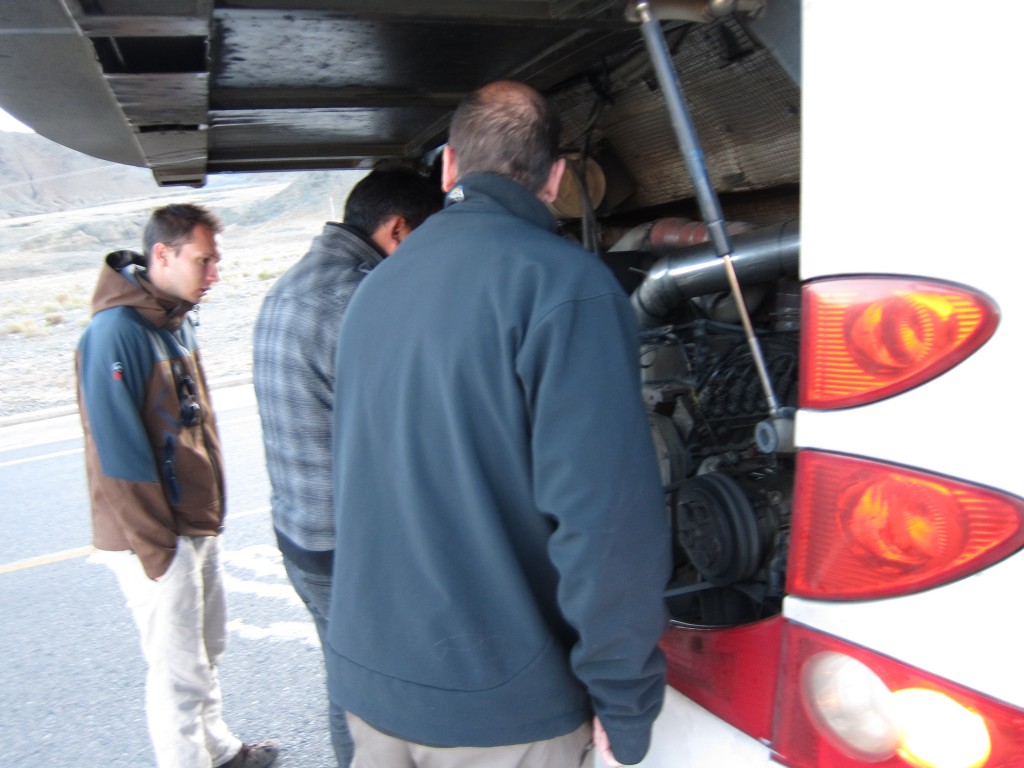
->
[641,256,799,626]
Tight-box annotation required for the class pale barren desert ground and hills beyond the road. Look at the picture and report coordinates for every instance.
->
[0,132,362,424]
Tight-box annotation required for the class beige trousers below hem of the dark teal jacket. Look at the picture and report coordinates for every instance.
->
[346,713,592,768]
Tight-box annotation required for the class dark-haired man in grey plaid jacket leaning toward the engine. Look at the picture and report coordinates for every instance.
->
[253,169,443,768]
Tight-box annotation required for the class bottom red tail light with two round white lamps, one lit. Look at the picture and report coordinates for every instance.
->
[772,623,1024,768]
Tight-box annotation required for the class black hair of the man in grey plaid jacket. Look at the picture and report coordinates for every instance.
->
[345,168,444,234]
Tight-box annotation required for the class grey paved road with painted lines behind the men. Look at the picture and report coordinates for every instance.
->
[0,386,333,768]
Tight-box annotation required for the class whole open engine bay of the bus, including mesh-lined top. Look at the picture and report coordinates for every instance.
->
[536,6,800,627]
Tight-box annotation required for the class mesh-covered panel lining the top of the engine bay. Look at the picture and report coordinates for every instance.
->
[556,18,800,208]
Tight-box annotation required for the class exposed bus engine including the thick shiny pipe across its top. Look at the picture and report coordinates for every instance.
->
[611,214,800,627]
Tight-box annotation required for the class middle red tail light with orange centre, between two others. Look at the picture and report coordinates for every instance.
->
[787,451,1024,599]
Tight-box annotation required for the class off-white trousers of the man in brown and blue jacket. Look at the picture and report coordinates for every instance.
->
[95,537,242,768]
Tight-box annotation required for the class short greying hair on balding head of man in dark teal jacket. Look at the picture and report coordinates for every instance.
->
[449,80,561,193]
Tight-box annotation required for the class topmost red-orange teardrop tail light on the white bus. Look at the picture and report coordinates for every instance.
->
[800,278,998,409]
